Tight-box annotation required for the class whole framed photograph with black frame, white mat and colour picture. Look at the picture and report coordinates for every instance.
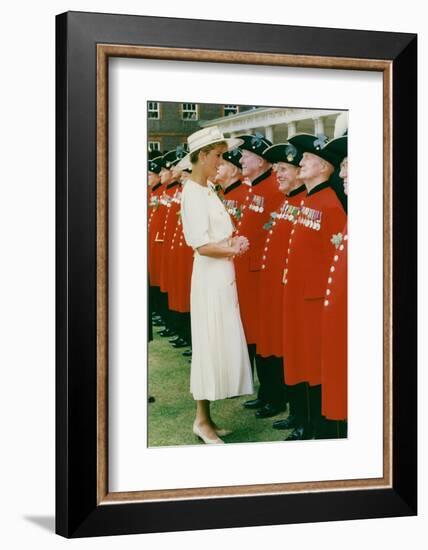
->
[56,12,417,537]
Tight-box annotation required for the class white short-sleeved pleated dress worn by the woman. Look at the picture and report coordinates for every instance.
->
[181,179,253,401]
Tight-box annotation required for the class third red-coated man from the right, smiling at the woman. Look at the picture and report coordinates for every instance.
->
[251,143,306,418]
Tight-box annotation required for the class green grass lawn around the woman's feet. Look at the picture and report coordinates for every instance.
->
[148,330,289,447]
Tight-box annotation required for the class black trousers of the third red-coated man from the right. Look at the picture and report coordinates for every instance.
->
[256,354,288,408]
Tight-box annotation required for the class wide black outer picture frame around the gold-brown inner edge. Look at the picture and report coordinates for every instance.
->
[56,12,417,537]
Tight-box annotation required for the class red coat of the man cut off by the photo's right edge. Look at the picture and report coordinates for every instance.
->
[321,222,348,420]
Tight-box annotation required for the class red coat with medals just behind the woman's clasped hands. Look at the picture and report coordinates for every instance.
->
[235,170,284,344]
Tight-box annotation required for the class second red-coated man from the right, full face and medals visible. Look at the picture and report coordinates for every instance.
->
[283,134,346,440]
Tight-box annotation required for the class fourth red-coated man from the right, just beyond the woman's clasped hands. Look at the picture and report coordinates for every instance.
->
[231,134,284,409]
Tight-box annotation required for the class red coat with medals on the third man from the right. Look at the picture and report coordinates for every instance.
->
[256,186,306,357]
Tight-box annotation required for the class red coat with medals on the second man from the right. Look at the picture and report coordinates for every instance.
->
[283,183,346,385]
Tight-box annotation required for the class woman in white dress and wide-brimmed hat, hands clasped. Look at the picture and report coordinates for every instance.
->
[180,127,253,443]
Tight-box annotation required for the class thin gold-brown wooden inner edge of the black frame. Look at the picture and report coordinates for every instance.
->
[97,44,393,505]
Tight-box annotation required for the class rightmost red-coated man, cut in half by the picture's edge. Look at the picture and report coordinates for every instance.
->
[320,136,348,439]
